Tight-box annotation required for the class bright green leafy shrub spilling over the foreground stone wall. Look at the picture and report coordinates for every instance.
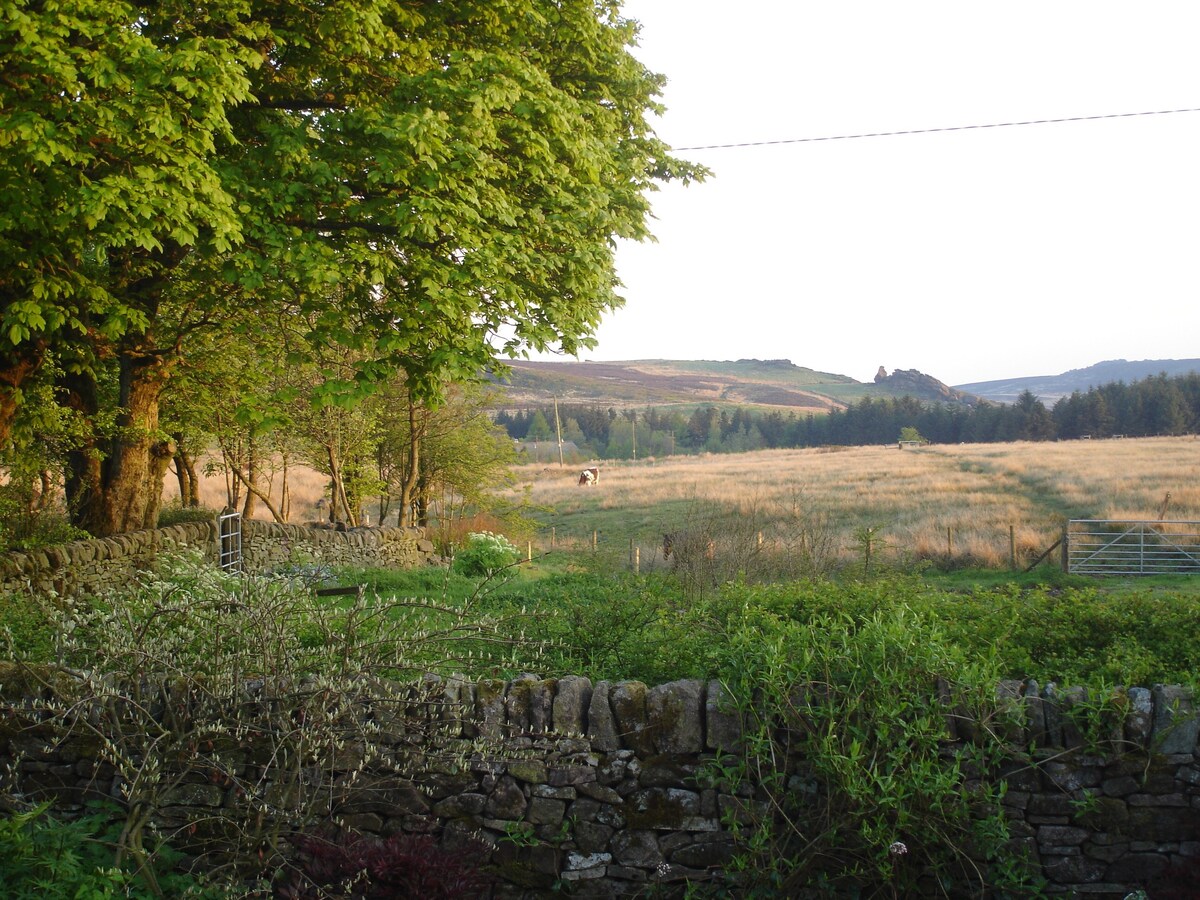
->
[709,604,1041,896]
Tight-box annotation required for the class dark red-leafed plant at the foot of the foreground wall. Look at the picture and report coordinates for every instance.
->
[275,832,490,900]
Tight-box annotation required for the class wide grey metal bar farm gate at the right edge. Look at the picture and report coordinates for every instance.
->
[1066,518,1200,575]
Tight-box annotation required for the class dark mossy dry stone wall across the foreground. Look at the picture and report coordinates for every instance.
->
[0,676,1200,898]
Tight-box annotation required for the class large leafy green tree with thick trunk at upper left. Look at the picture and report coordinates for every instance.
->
[0,0,704,534]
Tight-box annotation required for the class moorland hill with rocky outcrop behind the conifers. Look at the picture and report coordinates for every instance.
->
[499,359,976,413]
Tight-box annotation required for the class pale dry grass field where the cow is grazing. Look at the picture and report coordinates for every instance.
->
[508,437,1200,565]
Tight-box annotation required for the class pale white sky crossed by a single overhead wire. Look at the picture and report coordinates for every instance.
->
[540,0,1200,384]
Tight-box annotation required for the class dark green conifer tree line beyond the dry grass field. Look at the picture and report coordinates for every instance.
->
[496,373,1200,460]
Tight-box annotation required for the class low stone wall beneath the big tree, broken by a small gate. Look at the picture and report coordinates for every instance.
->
[0,521,433,595]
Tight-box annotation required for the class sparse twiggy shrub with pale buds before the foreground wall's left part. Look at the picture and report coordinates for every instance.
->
[2,556,535,890]
